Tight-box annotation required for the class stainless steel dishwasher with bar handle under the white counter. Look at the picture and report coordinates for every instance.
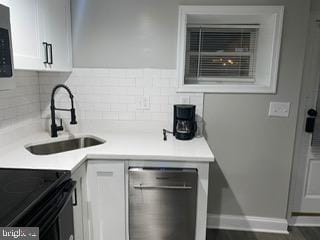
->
[129,168,198,240]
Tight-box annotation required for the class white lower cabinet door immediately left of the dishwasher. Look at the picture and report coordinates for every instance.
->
[87,160,126,240]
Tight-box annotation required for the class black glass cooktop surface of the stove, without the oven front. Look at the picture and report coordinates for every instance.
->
[0,169,70,227]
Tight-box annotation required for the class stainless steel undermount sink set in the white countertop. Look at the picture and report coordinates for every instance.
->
[26,137,105,155]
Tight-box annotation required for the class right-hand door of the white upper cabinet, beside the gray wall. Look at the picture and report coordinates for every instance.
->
[42,0,72,71]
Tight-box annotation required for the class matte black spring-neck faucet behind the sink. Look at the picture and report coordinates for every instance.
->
[50,84,77,137]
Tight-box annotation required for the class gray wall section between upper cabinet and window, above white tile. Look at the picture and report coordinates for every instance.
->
[72,0,178,68]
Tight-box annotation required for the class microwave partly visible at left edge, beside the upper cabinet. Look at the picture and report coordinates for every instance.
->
[0,4,14,90]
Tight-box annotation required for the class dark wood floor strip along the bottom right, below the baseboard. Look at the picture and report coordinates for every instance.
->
[207,227,320,240]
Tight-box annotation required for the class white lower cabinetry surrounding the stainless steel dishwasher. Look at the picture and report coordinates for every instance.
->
[76,159,209,240]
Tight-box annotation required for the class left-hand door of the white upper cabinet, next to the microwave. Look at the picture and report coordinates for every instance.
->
[0,0,44,70]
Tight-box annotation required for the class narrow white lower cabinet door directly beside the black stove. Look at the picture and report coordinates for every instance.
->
[71,164,87,240]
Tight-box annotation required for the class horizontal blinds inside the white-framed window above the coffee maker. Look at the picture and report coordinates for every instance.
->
[185,25,259,84]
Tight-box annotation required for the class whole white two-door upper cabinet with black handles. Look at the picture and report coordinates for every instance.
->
[0,0,72,71]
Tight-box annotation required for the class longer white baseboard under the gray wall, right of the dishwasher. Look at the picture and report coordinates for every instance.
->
[207,214,288,234]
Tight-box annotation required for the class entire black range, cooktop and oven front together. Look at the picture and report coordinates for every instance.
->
[0,169,75,240]
